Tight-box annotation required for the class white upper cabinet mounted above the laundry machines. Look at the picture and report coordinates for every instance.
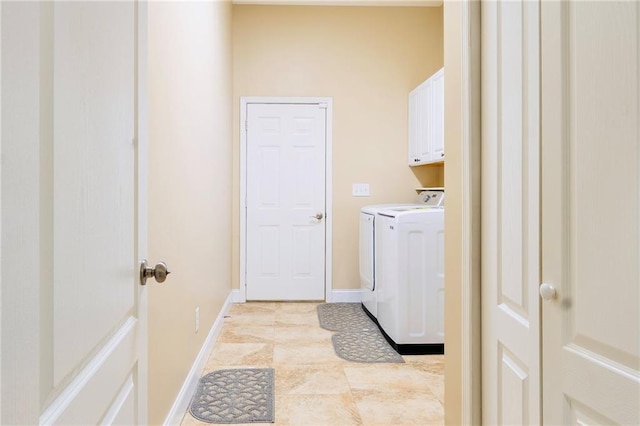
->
[408,68,444,166]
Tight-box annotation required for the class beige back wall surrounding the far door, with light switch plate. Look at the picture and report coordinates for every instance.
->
[232,5,443,289]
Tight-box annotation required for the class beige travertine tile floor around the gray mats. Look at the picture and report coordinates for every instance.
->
[182,302,444,426]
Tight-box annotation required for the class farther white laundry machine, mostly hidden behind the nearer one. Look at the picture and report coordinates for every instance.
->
[359,188,442,320]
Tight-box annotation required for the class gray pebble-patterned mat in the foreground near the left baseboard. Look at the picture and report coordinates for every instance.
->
[190,368,275,424]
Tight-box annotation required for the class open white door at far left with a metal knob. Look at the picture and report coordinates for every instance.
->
[0,2,147,425]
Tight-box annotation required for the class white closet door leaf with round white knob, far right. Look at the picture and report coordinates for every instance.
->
[541,1,640,425]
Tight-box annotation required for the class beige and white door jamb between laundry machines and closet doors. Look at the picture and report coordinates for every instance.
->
[443,0,482,424]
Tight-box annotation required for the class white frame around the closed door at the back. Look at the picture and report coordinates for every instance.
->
[235,96,333,303]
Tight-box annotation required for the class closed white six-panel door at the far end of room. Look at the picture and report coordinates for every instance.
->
[245,103,327,300]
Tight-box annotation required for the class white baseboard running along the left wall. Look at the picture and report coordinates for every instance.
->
[164,290,235,425]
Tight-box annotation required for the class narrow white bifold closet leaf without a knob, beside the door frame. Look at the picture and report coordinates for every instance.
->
[481,0,540,425]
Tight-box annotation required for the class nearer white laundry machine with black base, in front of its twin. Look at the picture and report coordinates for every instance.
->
[375,191,444,354]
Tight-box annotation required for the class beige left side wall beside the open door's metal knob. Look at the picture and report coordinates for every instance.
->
[149,1,231,424]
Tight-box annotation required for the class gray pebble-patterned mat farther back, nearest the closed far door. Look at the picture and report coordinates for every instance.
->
[318,303,378,331]
